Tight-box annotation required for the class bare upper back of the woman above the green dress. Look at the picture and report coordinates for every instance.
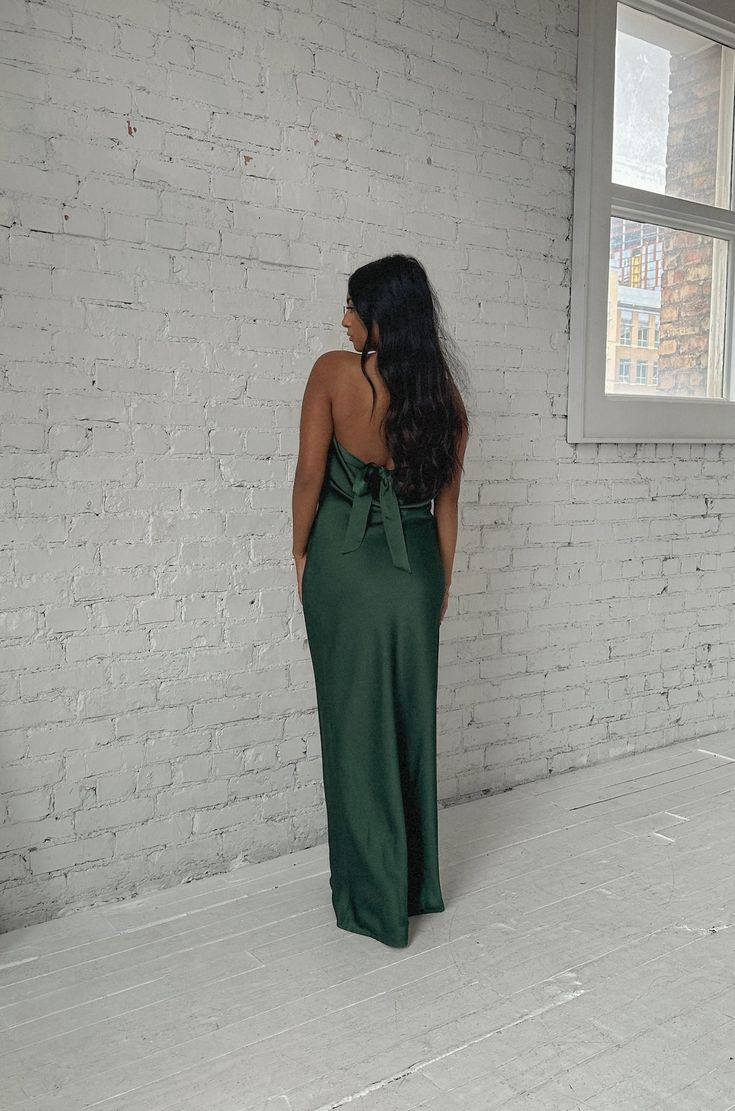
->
[332,351,395,469]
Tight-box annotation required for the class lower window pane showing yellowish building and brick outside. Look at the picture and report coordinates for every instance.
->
[605,217,727,398]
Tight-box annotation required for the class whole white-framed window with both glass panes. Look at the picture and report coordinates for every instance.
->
[567,0,735,443]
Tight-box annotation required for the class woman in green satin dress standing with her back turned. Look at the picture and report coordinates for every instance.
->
[293,254,469,947]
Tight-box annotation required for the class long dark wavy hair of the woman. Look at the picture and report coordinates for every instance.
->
[348,254,470,501]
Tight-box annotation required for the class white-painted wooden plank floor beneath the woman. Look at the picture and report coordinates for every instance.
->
[0,733,735,1111]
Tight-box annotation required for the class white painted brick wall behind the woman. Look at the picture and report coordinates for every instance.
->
[0,0,735,929]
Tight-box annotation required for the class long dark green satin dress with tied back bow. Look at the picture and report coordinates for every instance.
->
[302,437,444,947]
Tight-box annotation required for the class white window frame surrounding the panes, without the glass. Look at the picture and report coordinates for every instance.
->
[566,0,735,443]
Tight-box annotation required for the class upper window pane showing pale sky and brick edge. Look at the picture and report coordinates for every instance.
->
[613,3,734,208]
